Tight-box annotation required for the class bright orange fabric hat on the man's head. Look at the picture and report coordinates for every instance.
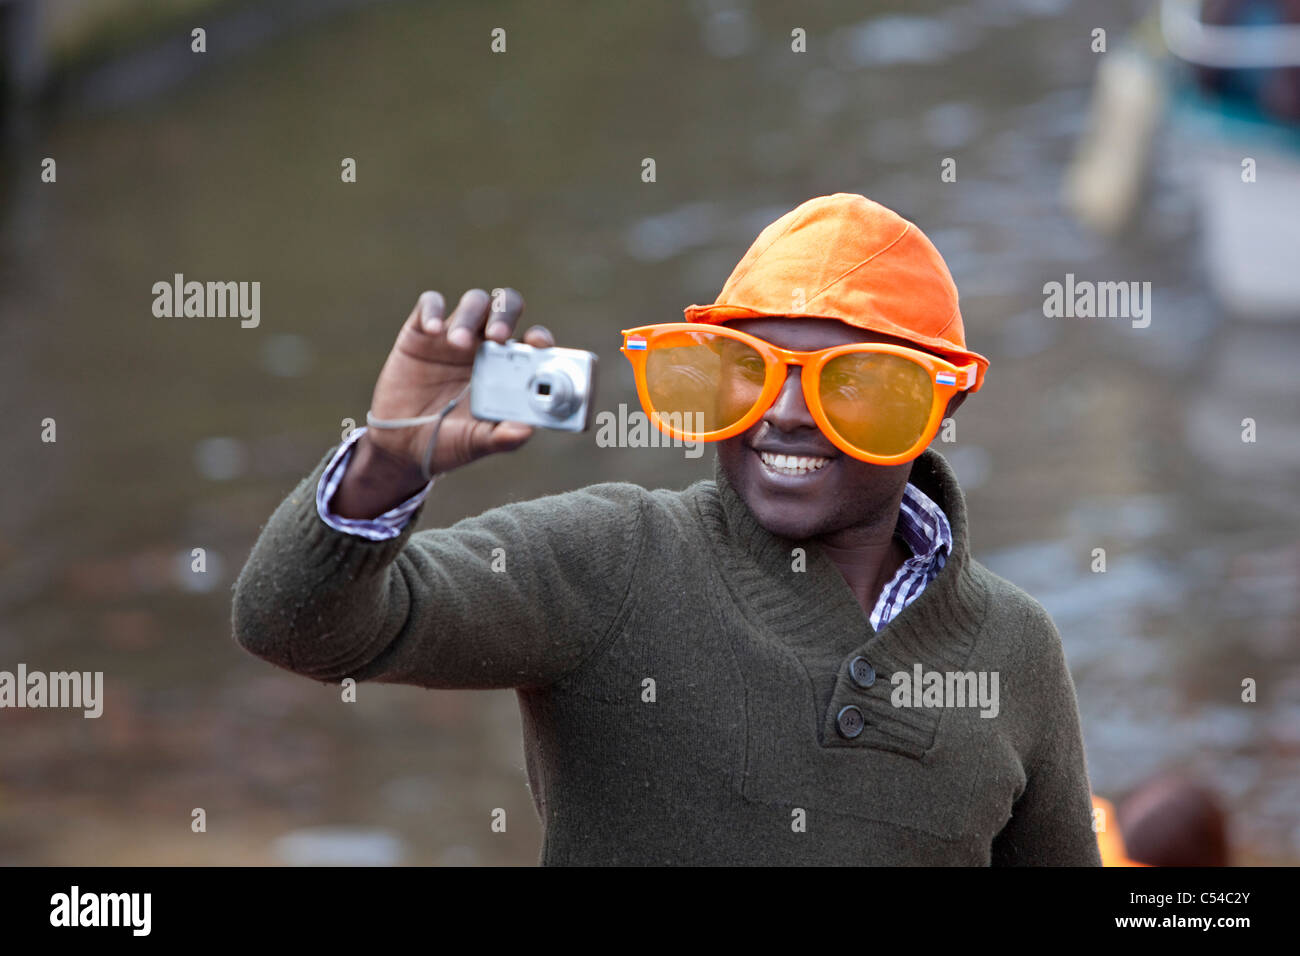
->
[685,193,988,392]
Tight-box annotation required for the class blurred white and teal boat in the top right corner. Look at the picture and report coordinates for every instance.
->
[1065,0,1300,320]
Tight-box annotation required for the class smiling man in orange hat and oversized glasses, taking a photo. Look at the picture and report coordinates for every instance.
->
[234,194,1100,865]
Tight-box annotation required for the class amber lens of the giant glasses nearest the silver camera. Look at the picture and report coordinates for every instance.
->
[645,332,767,434]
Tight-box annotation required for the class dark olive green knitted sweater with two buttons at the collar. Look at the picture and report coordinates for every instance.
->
[234,450,1100,866]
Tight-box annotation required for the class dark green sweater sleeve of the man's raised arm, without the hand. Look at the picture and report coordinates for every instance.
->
[234,444,644,688]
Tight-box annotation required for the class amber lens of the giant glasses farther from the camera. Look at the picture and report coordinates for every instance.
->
[818,352,935,457]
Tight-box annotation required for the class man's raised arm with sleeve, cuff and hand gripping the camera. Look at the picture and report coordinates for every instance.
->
[234,289,645,688]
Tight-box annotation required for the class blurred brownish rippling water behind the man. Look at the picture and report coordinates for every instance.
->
[0,0,1300,865]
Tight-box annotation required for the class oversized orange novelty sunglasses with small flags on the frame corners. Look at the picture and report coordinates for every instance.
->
[620,323,978,464]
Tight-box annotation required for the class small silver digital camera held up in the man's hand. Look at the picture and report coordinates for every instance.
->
[469,339,595,432]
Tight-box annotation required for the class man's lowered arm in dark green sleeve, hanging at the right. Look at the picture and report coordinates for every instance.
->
[992,605,1101,866]
